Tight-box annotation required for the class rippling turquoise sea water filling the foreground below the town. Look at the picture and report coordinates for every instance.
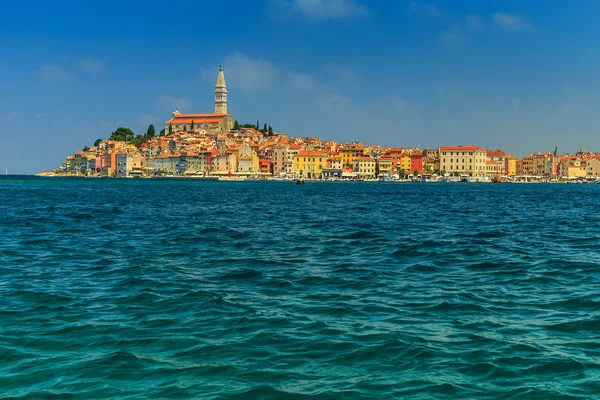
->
[0,178,600,399]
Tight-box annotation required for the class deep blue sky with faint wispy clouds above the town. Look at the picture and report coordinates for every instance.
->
[0,0,600,174]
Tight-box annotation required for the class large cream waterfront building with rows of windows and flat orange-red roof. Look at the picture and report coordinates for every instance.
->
[439,146,486,177]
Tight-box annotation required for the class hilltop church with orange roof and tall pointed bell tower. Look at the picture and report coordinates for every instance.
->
[165,65,233,132]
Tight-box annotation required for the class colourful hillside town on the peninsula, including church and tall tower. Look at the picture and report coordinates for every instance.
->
[37,66,600,183]
